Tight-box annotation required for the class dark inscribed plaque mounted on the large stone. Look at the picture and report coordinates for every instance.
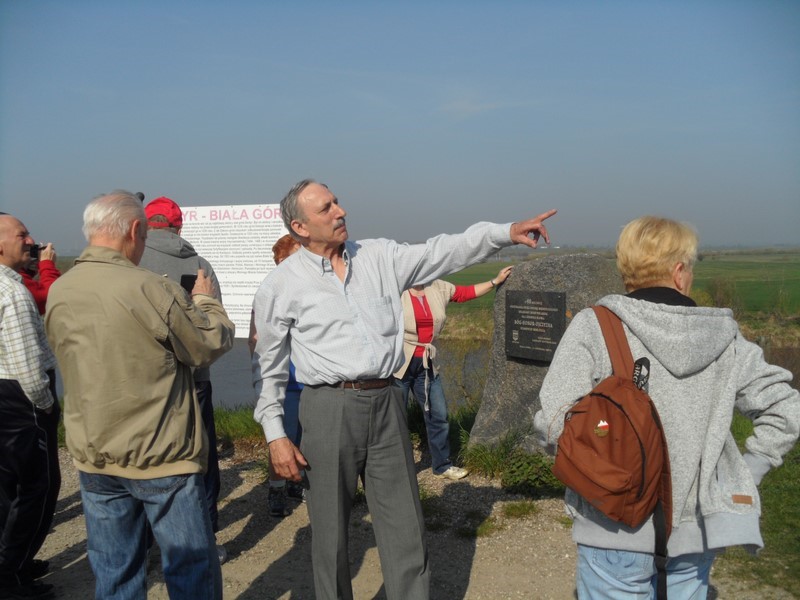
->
[506,290,567,362]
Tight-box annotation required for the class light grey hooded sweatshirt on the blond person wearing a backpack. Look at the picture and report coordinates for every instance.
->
[534,288,800,556]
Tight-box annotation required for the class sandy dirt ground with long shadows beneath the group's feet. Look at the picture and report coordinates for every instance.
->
[39,445,792,600]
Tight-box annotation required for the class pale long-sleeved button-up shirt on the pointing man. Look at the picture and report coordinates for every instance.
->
[252,223,512,442]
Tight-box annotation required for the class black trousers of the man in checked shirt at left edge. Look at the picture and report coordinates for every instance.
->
[0,380,51,582]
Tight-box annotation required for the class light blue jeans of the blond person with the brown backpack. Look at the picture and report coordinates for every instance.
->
[576,544,716,600]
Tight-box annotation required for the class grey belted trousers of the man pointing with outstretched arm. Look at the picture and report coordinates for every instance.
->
[300,385,430,600]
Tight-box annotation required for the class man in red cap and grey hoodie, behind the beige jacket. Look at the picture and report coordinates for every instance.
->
[139,196,227,563]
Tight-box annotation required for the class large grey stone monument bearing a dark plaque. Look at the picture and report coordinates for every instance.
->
[469,254,625,452]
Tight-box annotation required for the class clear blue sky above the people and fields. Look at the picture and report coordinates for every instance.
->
[0,0,800,254]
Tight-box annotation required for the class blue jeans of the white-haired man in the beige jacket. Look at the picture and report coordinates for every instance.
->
[79,472,222,600]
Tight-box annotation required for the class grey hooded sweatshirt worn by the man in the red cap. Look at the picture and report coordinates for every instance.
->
[139,229,222,381]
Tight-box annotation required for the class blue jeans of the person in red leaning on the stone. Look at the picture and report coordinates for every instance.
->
[399,357,453,475]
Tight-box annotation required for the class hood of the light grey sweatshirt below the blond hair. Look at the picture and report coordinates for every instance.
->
[598,295,739,377]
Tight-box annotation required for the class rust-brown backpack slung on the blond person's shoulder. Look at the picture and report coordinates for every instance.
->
[553,306,672,598]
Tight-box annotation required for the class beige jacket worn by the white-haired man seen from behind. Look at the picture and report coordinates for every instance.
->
[45,246,235,479]
